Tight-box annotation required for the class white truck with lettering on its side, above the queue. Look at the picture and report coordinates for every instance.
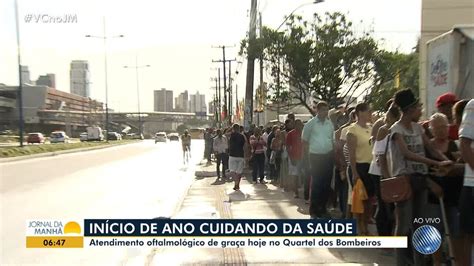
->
[426,24,474,116]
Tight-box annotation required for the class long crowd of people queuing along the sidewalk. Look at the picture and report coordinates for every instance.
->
[194,89,474,265]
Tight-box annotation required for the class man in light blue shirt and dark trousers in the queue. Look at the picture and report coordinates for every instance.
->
[302,101,334,218]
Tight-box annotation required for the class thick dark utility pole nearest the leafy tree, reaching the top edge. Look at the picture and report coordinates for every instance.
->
[244,0,257,130]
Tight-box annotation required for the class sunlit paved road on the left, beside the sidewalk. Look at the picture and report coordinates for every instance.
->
[0,141,204,265]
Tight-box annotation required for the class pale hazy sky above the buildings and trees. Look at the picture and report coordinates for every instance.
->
[0,0,421,111]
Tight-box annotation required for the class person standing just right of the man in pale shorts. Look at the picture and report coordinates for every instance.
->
[250,128,267,184]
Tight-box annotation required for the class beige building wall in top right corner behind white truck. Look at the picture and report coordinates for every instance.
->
[419,0,474,115]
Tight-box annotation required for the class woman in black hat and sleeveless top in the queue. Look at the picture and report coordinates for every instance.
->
[381,89,453,265]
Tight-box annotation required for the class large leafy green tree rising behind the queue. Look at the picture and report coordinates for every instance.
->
[241,12,380,112]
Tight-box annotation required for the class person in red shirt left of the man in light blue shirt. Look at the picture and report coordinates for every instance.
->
[286,119,304,198]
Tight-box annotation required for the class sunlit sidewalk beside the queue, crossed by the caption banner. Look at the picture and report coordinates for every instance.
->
[148,164,395,265]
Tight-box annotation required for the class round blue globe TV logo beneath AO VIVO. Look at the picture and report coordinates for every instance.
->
[412,225,442,255]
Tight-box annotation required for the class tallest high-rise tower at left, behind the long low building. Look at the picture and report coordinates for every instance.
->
[69,60,90,97]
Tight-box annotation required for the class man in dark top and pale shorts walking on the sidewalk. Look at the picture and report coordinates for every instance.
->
[229,124,247,190]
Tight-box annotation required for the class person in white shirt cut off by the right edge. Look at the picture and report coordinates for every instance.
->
[456,100,474,265]
